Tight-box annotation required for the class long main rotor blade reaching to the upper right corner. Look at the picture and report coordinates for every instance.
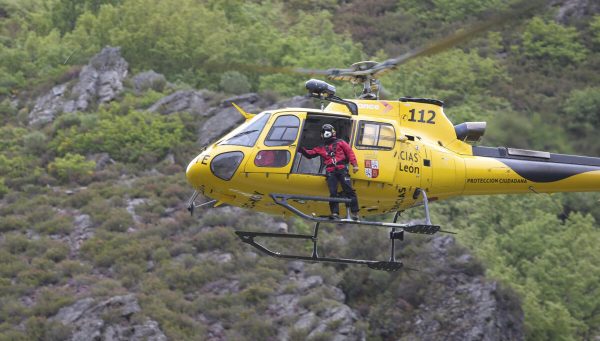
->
[372,0,547,76]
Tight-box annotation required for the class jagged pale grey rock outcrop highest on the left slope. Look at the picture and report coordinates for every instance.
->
[29,47,128,125]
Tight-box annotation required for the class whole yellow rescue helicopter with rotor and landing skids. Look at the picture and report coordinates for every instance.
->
[186,0,600,271]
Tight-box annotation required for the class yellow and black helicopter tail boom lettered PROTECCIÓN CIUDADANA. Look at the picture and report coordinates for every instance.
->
[463,147,600,194]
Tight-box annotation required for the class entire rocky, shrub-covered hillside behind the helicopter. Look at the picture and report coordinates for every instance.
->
[0,0,600,340]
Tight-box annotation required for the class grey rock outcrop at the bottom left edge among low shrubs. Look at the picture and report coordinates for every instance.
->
[51,294,167,341]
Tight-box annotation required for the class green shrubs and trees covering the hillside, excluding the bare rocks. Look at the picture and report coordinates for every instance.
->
[0,0,600,340]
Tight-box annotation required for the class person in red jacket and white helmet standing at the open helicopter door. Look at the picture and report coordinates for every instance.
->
[300,124,359,220]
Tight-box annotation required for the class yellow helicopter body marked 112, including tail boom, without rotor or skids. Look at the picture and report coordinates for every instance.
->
[186,99,600,216]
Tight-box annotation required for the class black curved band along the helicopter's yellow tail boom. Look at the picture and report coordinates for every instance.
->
[473,146,600,182]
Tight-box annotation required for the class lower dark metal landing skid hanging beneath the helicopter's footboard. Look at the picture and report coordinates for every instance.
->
[235,223,404,271]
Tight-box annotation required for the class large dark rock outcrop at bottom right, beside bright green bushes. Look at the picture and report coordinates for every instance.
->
[395,236,524,341]
